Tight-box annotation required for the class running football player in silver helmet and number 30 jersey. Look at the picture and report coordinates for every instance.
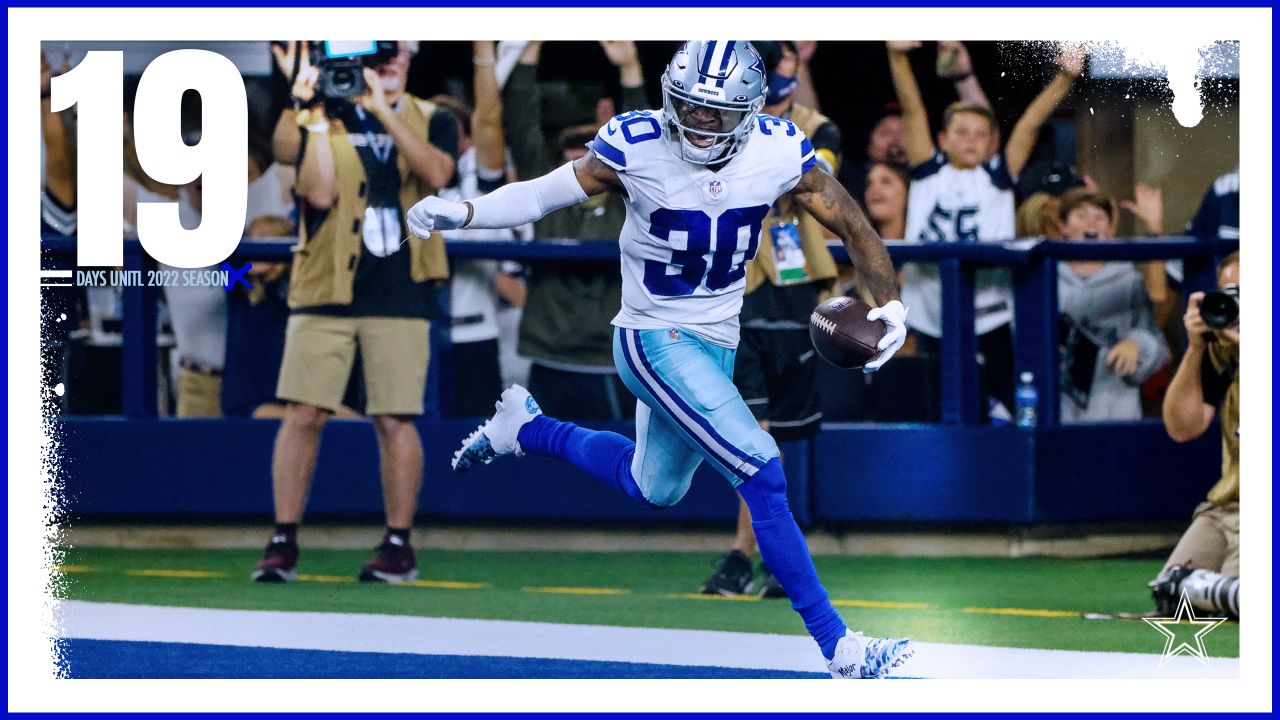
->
[407,40,911,678]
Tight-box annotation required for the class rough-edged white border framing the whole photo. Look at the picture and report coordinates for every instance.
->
[9,8,1272,712]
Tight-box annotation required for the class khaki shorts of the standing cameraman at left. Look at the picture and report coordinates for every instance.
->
[275,313,430,415]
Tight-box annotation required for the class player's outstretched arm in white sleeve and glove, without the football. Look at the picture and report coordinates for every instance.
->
[406,155,622,237]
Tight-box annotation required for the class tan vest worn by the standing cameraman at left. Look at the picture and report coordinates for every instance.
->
[289,94,449,309]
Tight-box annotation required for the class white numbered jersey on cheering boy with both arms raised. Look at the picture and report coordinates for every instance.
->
[902,151,1016,337]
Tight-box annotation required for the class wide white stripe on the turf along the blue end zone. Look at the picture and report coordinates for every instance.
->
[58,601,1240,679]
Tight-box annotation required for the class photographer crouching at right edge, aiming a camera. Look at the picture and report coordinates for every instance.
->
[1151,252,1240,618]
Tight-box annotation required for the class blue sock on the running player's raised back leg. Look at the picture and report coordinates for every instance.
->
[517,415,657,507]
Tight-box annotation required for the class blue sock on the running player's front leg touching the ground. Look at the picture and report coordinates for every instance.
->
[737,457,846,660]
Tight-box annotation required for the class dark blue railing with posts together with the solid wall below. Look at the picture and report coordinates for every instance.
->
[42,237,1239,525]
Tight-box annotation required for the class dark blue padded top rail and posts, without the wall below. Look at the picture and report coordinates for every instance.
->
[42,237,1239,427]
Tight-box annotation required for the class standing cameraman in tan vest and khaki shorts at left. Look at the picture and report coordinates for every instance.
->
[252,41,457,582]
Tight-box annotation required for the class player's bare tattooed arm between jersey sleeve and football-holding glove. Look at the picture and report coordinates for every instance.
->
[791,167,897,305]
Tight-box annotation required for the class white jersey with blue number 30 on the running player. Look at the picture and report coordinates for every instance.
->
[591,110,817,347]
